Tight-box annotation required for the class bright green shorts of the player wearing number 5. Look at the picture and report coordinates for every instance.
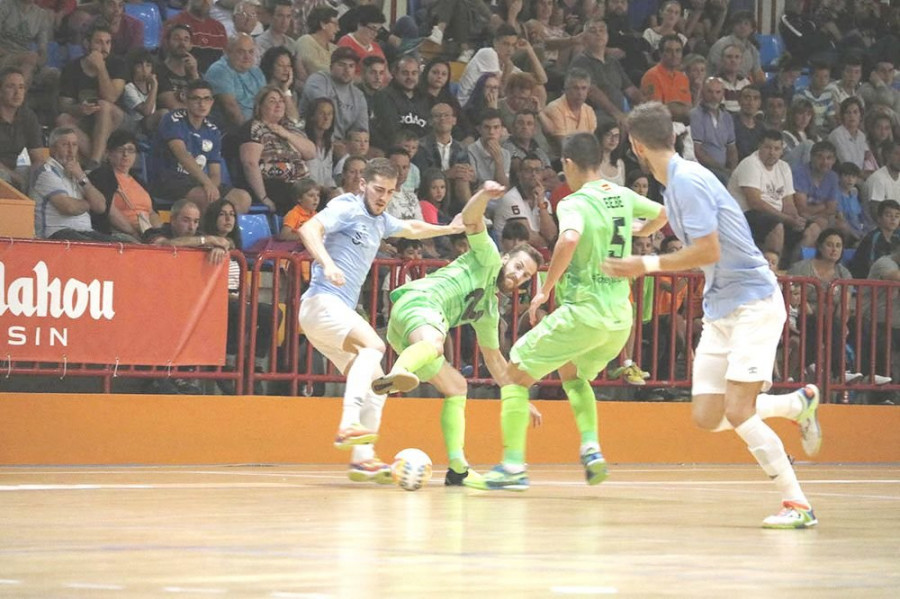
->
[509,305,631,381]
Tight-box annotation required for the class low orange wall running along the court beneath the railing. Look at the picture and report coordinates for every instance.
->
[0,393,900,465]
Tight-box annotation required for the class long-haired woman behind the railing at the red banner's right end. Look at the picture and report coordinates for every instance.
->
[200,198,277,386]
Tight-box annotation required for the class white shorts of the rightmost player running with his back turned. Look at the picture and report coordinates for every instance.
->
[691,291,787,395]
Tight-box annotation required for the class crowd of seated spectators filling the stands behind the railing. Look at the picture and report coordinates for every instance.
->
[0,0,900,400]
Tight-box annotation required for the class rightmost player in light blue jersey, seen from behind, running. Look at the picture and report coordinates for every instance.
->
[604,102,822,528]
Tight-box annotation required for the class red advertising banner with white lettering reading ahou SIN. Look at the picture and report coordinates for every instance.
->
[0,240,228,366]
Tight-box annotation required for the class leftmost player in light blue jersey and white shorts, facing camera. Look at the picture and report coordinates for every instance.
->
[300,158,464,483]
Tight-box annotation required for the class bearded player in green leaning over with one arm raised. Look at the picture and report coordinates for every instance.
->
[372,181,542,486]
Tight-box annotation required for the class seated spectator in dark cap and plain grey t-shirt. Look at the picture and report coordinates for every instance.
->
[300,47,369,139]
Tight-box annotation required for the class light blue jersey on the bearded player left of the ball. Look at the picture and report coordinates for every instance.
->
[303,193,403,310]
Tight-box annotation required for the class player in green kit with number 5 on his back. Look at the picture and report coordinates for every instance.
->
[465,133,666,491]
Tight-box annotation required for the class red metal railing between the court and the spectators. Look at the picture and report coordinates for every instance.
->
[7,246,900,406]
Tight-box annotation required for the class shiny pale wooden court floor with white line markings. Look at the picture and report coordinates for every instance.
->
[0,464,900,599]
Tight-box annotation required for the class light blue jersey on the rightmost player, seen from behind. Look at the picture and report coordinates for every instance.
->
[663,155,778,320]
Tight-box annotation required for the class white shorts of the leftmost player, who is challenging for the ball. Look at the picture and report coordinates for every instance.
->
[300,293,370,374]
